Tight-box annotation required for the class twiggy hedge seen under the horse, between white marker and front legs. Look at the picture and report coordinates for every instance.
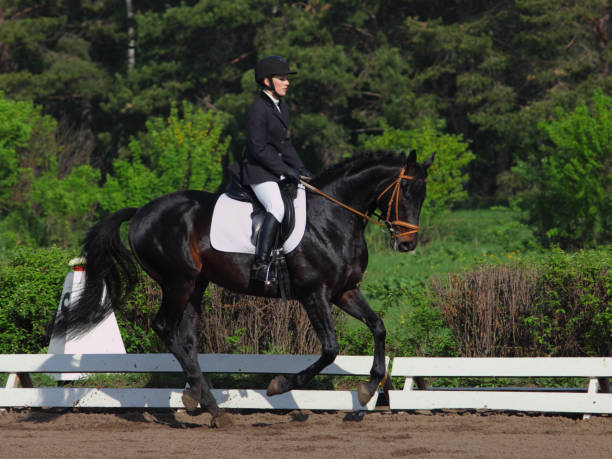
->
[99,275,319,354]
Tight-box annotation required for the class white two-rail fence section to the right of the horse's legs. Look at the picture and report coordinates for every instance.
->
[389,357,612,413]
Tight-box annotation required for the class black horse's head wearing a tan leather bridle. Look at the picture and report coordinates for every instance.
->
[378,151,435,252]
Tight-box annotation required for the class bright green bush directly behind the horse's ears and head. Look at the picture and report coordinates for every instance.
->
[362,121,474,216]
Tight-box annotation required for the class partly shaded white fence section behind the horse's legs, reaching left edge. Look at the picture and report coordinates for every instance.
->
[0,354,389,410]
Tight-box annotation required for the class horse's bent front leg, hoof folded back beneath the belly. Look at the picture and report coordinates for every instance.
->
[267,292,339,395]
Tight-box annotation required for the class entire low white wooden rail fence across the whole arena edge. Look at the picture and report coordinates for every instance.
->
[0,354,612,414]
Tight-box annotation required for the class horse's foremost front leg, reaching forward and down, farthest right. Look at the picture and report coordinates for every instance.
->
[334,288,391,406]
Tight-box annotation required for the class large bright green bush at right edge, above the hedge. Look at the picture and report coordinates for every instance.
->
[514,91,612,247]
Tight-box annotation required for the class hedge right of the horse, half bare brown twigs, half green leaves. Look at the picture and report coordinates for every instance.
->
[432,248,612,357]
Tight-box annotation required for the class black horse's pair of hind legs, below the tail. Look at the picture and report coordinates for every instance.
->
[153,282,227,425]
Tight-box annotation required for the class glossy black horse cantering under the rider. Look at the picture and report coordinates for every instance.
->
[62,152,433,425]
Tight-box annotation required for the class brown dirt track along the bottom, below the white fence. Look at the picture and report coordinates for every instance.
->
[0,410,612,459]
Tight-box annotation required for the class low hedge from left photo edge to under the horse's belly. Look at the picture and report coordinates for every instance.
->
[0,247,319,354]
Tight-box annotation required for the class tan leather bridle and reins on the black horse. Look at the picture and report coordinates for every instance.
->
[300,167,427,239]
